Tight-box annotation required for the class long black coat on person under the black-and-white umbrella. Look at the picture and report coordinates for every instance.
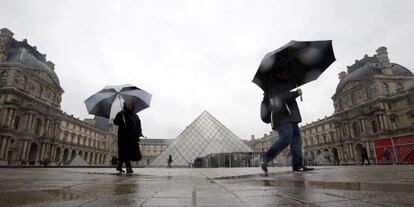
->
[114,109,142,161]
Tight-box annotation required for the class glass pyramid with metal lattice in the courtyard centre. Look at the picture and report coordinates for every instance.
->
[150,111,252,167]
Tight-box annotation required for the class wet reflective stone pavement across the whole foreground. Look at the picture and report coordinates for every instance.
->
[0,165,414,207]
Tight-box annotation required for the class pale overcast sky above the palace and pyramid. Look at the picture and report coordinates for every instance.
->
[0,0,414,139]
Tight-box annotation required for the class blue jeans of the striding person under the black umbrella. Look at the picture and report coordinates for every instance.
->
[262,123,303,170]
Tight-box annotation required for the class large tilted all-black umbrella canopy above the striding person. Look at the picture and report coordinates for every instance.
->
[253,40,335,91]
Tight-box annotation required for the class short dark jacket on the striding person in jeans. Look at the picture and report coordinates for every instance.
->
[267,81,302,130]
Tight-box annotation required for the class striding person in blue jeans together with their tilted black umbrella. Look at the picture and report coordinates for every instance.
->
[253,41,335,173]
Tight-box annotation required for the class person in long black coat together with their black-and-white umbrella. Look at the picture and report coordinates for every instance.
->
[85,84,152,173]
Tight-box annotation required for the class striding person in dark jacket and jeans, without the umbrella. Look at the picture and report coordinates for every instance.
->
[260,69,313,173]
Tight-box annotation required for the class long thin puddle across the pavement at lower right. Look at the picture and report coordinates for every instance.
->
[254,180,414,192]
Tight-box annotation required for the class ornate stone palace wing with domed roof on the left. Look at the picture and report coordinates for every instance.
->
[0,29,117,165]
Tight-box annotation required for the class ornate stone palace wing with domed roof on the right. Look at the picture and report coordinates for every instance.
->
[250,47,414,164]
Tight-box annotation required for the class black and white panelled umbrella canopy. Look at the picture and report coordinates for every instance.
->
[85,84,151,119]
